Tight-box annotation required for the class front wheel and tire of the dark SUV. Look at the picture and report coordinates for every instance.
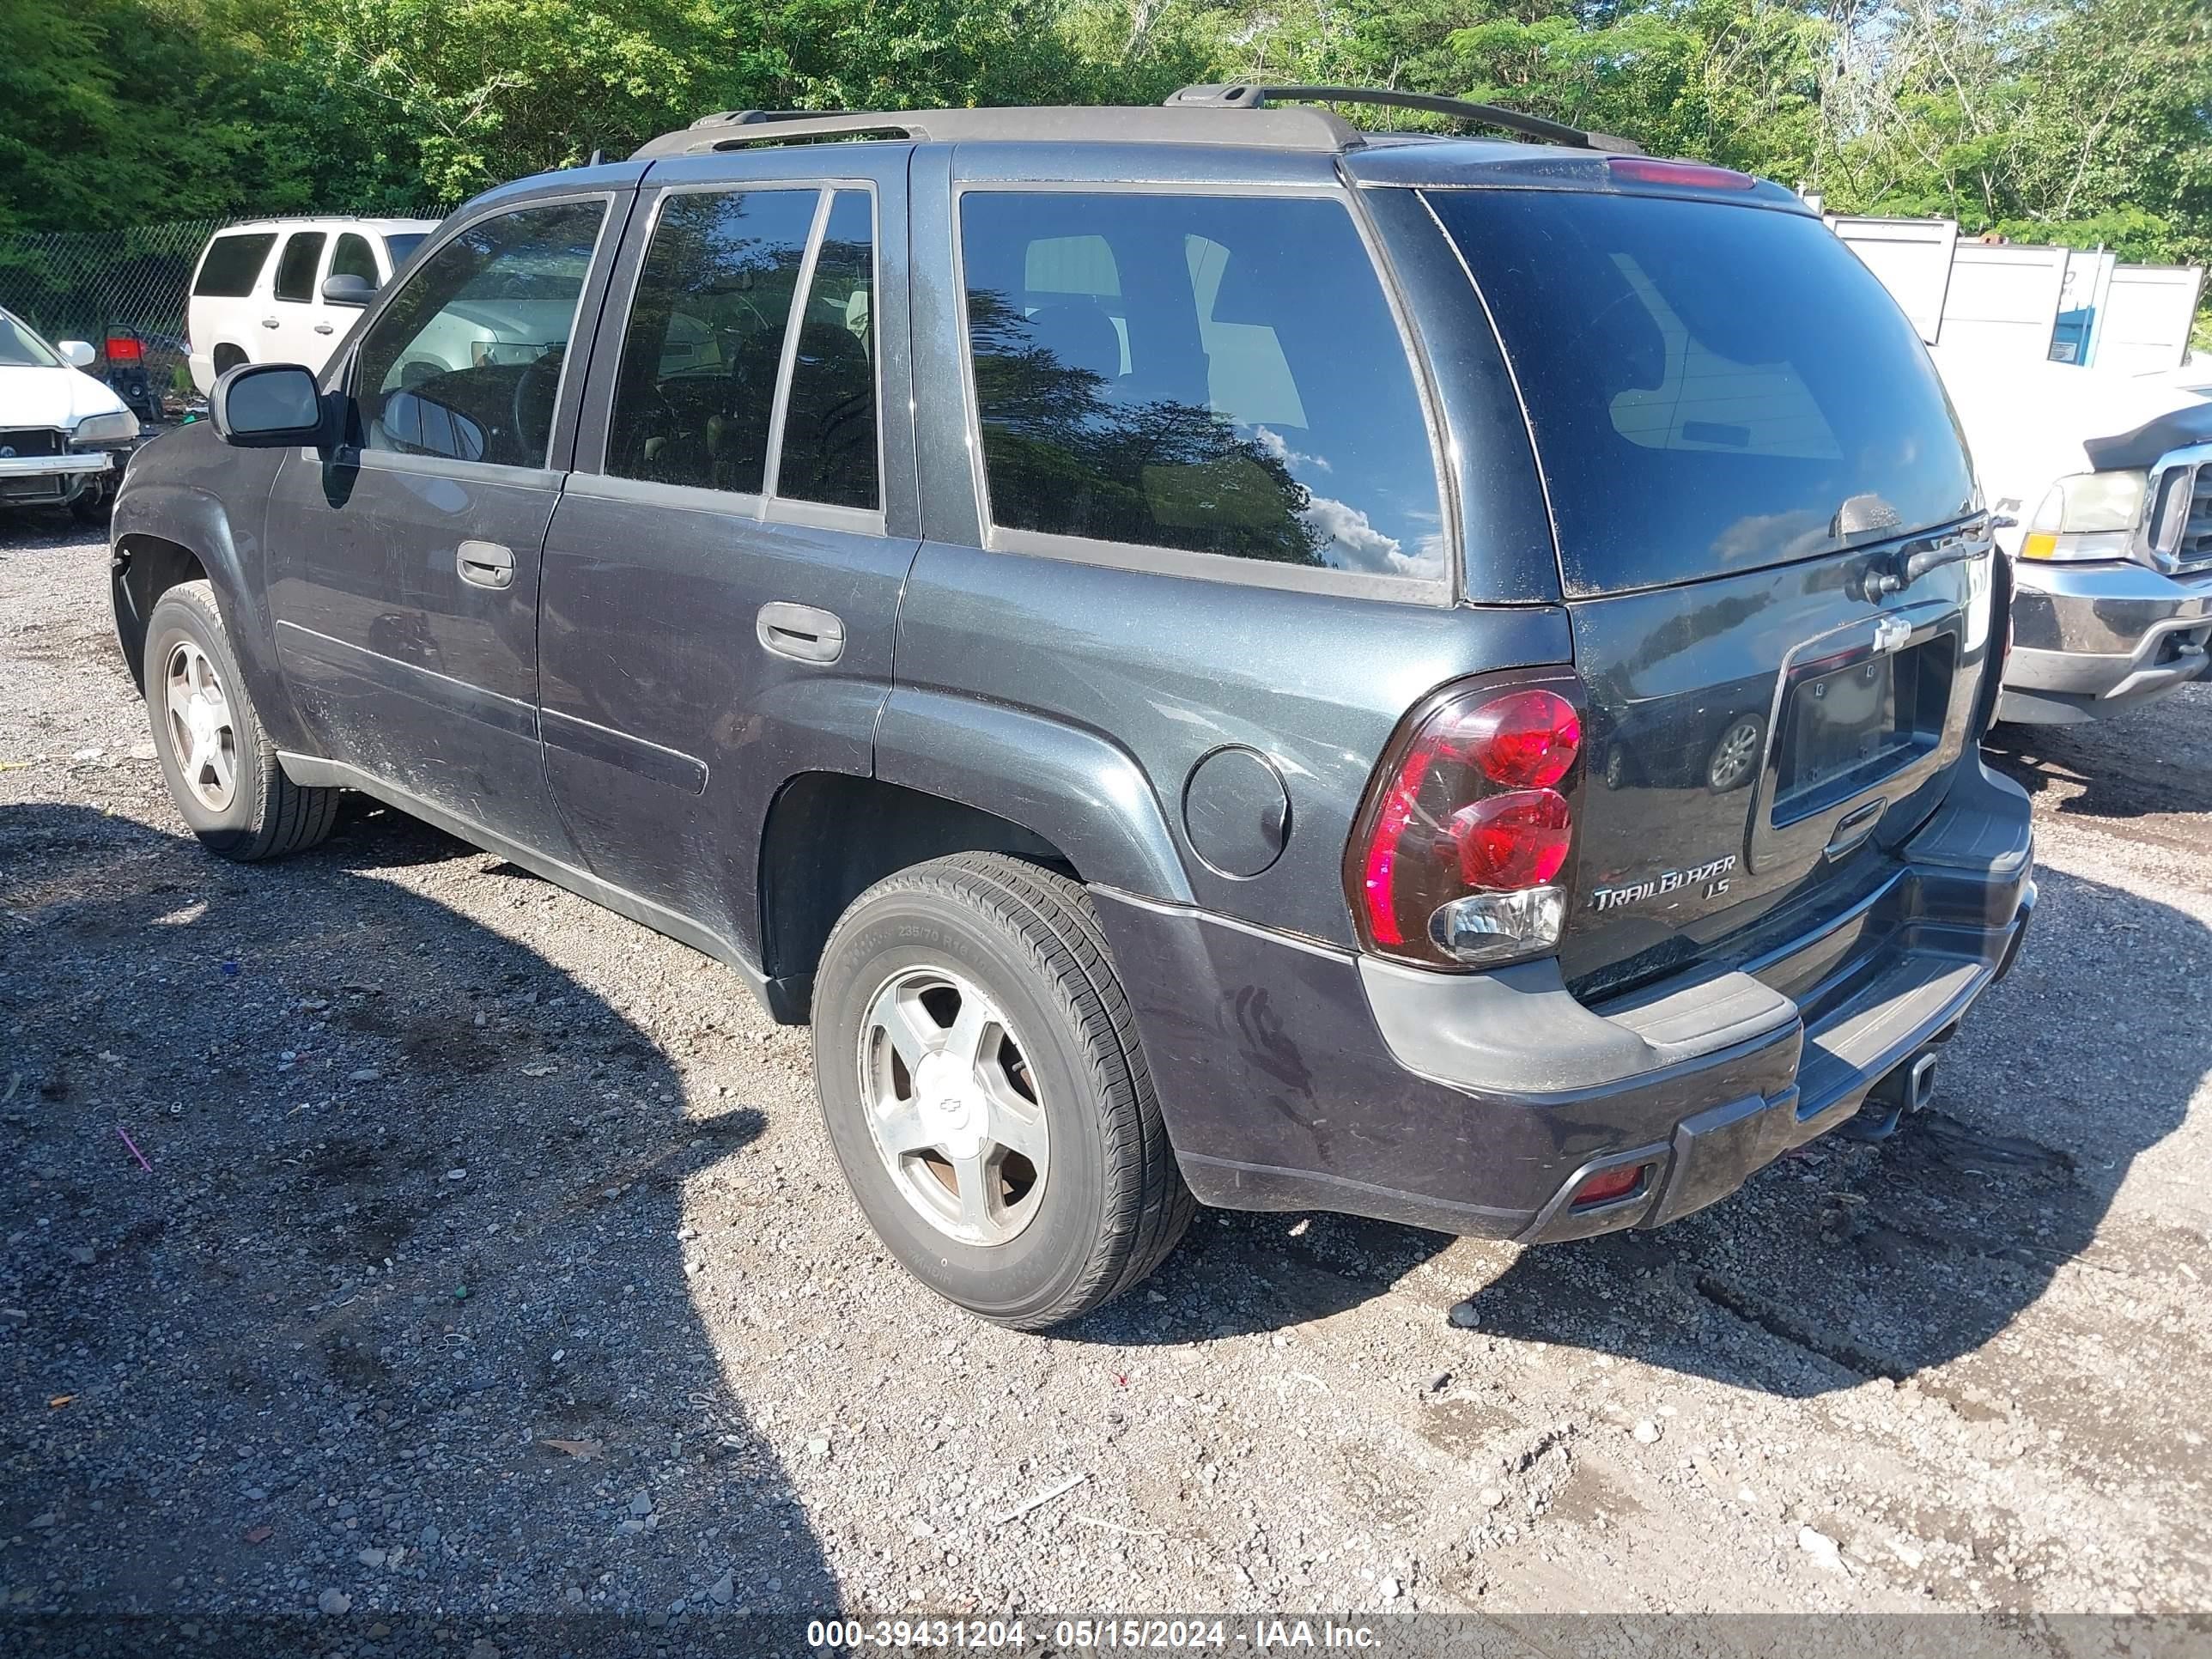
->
[146,581,338,863]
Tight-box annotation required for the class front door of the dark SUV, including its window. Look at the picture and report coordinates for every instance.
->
[268,191,626,858]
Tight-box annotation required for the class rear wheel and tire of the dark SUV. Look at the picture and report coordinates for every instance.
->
[814,854,1197,1329]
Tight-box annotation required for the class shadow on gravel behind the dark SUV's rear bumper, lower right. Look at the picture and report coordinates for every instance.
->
[1475,869,2212,1395]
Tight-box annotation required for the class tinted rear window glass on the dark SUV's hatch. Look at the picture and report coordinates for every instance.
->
[1429,191,1973,592]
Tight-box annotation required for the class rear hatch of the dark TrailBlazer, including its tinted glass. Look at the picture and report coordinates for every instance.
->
[1425,181,1990,995]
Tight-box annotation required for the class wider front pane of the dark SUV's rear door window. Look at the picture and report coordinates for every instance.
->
[606,191,818,495]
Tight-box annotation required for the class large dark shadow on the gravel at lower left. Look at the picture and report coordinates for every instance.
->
[0,805,836,1652]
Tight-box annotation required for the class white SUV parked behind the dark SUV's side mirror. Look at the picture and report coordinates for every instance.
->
[185,219,438,392]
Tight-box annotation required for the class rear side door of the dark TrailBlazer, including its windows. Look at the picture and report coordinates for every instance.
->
[540,143,921,963]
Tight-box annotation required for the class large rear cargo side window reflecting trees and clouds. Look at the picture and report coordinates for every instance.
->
[960,191,1447,580]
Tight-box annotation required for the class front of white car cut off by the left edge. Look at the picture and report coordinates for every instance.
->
[0,310,139,520]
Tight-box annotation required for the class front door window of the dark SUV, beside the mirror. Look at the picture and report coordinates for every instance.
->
[354,201,606,467]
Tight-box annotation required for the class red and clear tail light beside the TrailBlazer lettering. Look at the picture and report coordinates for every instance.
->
[1345,675,1582,967]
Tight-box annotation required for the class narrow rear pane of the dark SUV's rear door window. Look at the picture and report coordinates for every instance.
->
[776,191,883,507]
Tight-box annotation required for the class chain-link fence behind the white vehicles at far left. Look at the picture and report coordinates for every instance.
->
[0,206,445,420]
